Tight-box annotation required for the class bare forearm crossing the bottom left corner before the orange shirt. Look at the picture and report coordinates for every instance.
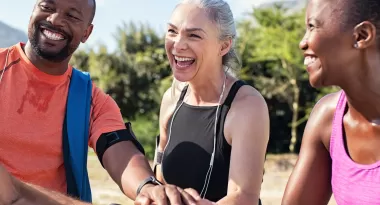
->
[0,166,88,205]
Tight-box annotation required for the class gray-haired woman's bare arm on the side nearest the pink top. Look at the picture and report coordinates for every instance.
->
[217,87,269,205]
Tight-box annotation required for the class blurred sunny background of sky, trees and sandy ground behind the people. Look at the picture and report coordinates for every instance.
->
[0,0,335,205]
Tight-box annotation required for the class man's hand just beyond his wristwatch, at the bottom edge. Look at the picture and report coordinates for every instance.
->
[135,184,199,205]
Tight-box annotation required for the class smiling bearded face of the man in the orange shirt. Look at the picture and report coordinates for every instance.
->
[28,0,94,62]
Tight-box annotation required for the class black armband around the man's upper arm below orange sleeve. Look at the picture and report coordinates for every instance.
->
[96,122,145,167]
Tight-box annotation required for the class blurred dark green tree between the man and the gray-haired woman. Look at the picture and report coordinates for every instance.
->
[71,22,171,157]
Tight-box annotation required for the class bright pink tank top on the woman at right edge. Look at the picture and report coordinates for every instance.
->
[330,91,380,205]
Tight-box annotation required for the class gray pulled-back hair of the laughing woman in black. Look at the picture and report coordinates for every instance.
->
[172,0,241,97]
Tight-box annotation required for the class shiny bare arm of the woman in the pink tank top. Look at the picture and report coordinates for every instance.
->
[282,94,338,205]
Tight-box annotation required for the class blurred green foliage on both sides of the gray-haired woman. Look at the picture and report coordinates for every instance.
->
[71,5,338,159]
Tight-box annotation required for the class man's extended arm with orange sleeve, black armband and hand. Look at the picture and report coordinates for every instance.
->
[90,87,194,205]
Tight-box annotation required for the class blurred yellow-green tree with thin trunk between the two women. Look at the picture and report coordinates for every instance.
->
[241,5,308,152]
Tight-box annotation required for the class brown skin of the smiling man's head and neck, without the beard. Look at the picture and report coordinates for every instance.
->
[24,0,94,75]
